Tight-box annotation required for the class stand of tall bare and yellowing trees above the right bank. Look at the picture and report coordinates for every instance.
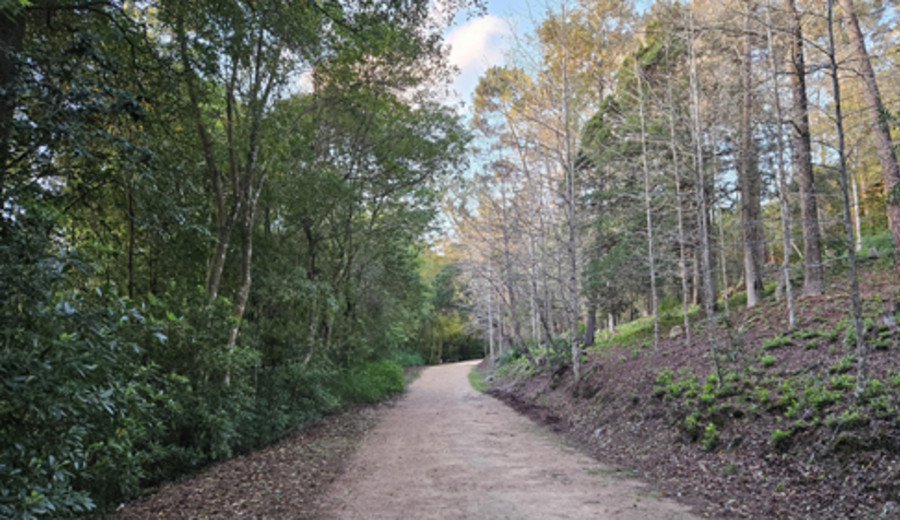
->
[459,0,896,386]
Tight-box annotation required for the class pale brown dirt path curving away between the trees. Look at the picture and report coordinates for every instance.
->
[323,362,695,520]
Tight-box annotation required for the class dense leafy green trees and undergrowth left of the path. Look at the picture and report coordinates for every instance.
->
[0,0,481,518]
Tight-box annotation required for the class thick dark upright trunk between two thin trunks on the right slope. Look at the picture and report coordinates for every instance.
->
[784,0,824,295]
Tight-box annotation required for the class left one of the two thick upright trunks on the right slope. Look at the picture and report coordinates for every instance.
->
[739,0,762,307]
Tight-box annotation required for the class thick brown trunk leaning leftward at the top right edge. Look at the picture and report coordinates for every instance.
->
[839,0,900,261]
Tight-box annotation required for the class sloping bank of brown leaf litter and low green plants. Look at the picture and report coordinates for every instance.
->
[489,262,900,520]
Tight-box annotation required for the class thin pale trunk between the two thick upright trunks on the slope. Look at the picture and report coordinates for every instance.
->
[766,2,795,330]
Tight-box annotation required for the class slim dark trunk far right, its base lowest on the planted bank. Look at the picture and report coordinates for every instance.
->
[828,0,869,398]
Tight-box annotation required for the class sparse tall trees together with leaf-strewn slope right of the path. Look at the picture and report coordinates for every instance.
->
[464,0,900,519]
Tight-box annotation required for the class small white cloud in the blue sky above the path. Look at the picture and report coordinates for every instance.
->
[446,15,510,100]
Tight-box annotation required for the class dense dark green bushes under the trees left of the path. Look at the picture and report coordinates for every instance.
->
[0,213,415,518]
